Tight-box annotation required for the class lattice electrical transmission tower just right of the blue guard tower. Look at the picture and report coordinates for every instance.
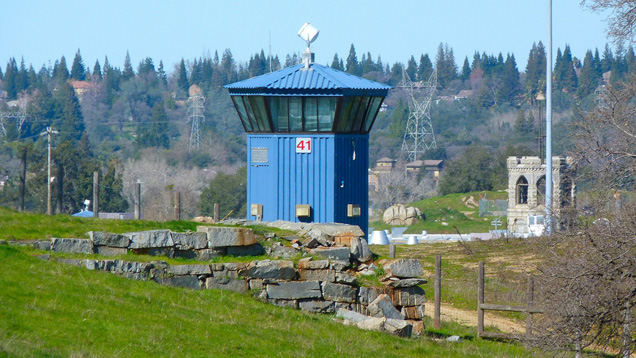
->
[398,67,437,162]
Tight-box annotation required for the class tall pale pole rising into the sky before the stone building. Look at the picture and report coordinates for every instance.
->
[545,0,554,235]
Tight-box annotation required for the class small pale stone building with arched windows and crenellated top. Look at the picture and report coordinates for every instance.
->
[507,156,576,237]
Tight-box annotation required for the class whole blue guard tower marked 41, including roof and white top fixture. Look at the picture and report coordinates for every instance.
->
[225,24,391,233]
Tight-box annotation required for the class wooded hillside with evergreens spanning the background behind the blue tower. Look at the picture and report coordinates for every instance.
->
[0,42,636,220]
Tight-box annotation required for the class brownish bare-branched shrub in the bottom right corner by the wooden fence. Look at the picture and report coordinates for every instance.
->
[531,204,636,356]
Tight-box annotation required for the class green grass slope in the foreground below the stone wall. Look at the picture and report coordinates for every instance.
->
[0,245,536,357]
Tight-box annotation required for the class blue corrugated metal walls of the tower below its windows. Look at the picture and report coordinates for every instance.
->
[247,134,369,232]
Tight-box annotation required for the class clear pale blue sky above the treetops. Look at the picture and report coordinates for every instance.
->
[0,0,609,72]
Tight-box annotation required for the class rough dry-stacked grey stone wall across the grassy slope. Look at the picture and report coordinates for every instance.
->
[24,227,426,336]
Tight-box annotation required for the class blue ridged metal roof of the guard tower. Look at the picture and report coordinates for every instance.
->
[225,63,392,97]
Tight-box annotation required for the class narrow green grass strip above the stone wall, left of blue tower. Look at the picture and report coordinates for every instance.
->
[0,207,291,240]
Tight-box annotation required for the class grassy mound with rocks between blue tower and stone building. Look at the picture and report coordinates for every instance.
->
[370,191,508,234]
